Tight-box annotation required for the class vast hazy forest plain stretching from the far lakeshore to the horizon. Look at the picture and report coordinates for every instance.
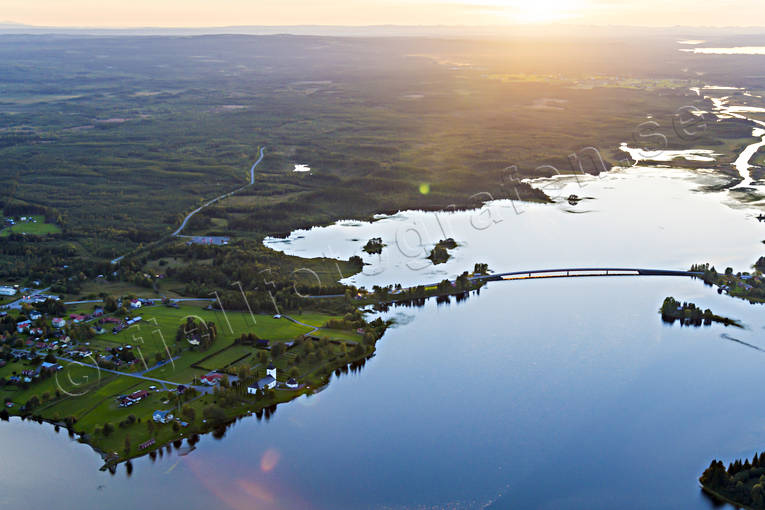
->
[0,35,756,283]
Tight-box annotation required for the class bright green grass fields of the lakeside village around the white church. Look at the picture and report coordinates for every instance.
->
[0,298,368,459]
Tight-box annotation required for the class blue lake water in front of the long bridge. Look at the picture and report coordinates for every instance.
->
[0,277,765,509]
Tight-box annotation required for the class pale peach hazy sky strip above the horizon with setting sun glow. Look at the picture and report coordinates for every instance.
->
[5,0,765,27]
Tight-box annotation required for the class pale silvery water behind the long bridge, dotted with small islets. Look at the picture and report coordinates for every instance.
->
[265,166,762,288]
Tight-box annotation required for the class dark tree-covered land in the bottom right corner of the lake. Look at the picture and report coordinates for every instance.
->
[699,453,765,510]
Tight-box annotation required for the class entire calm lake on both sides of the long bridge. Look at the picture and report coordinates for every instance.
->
[0,92,765,510]
